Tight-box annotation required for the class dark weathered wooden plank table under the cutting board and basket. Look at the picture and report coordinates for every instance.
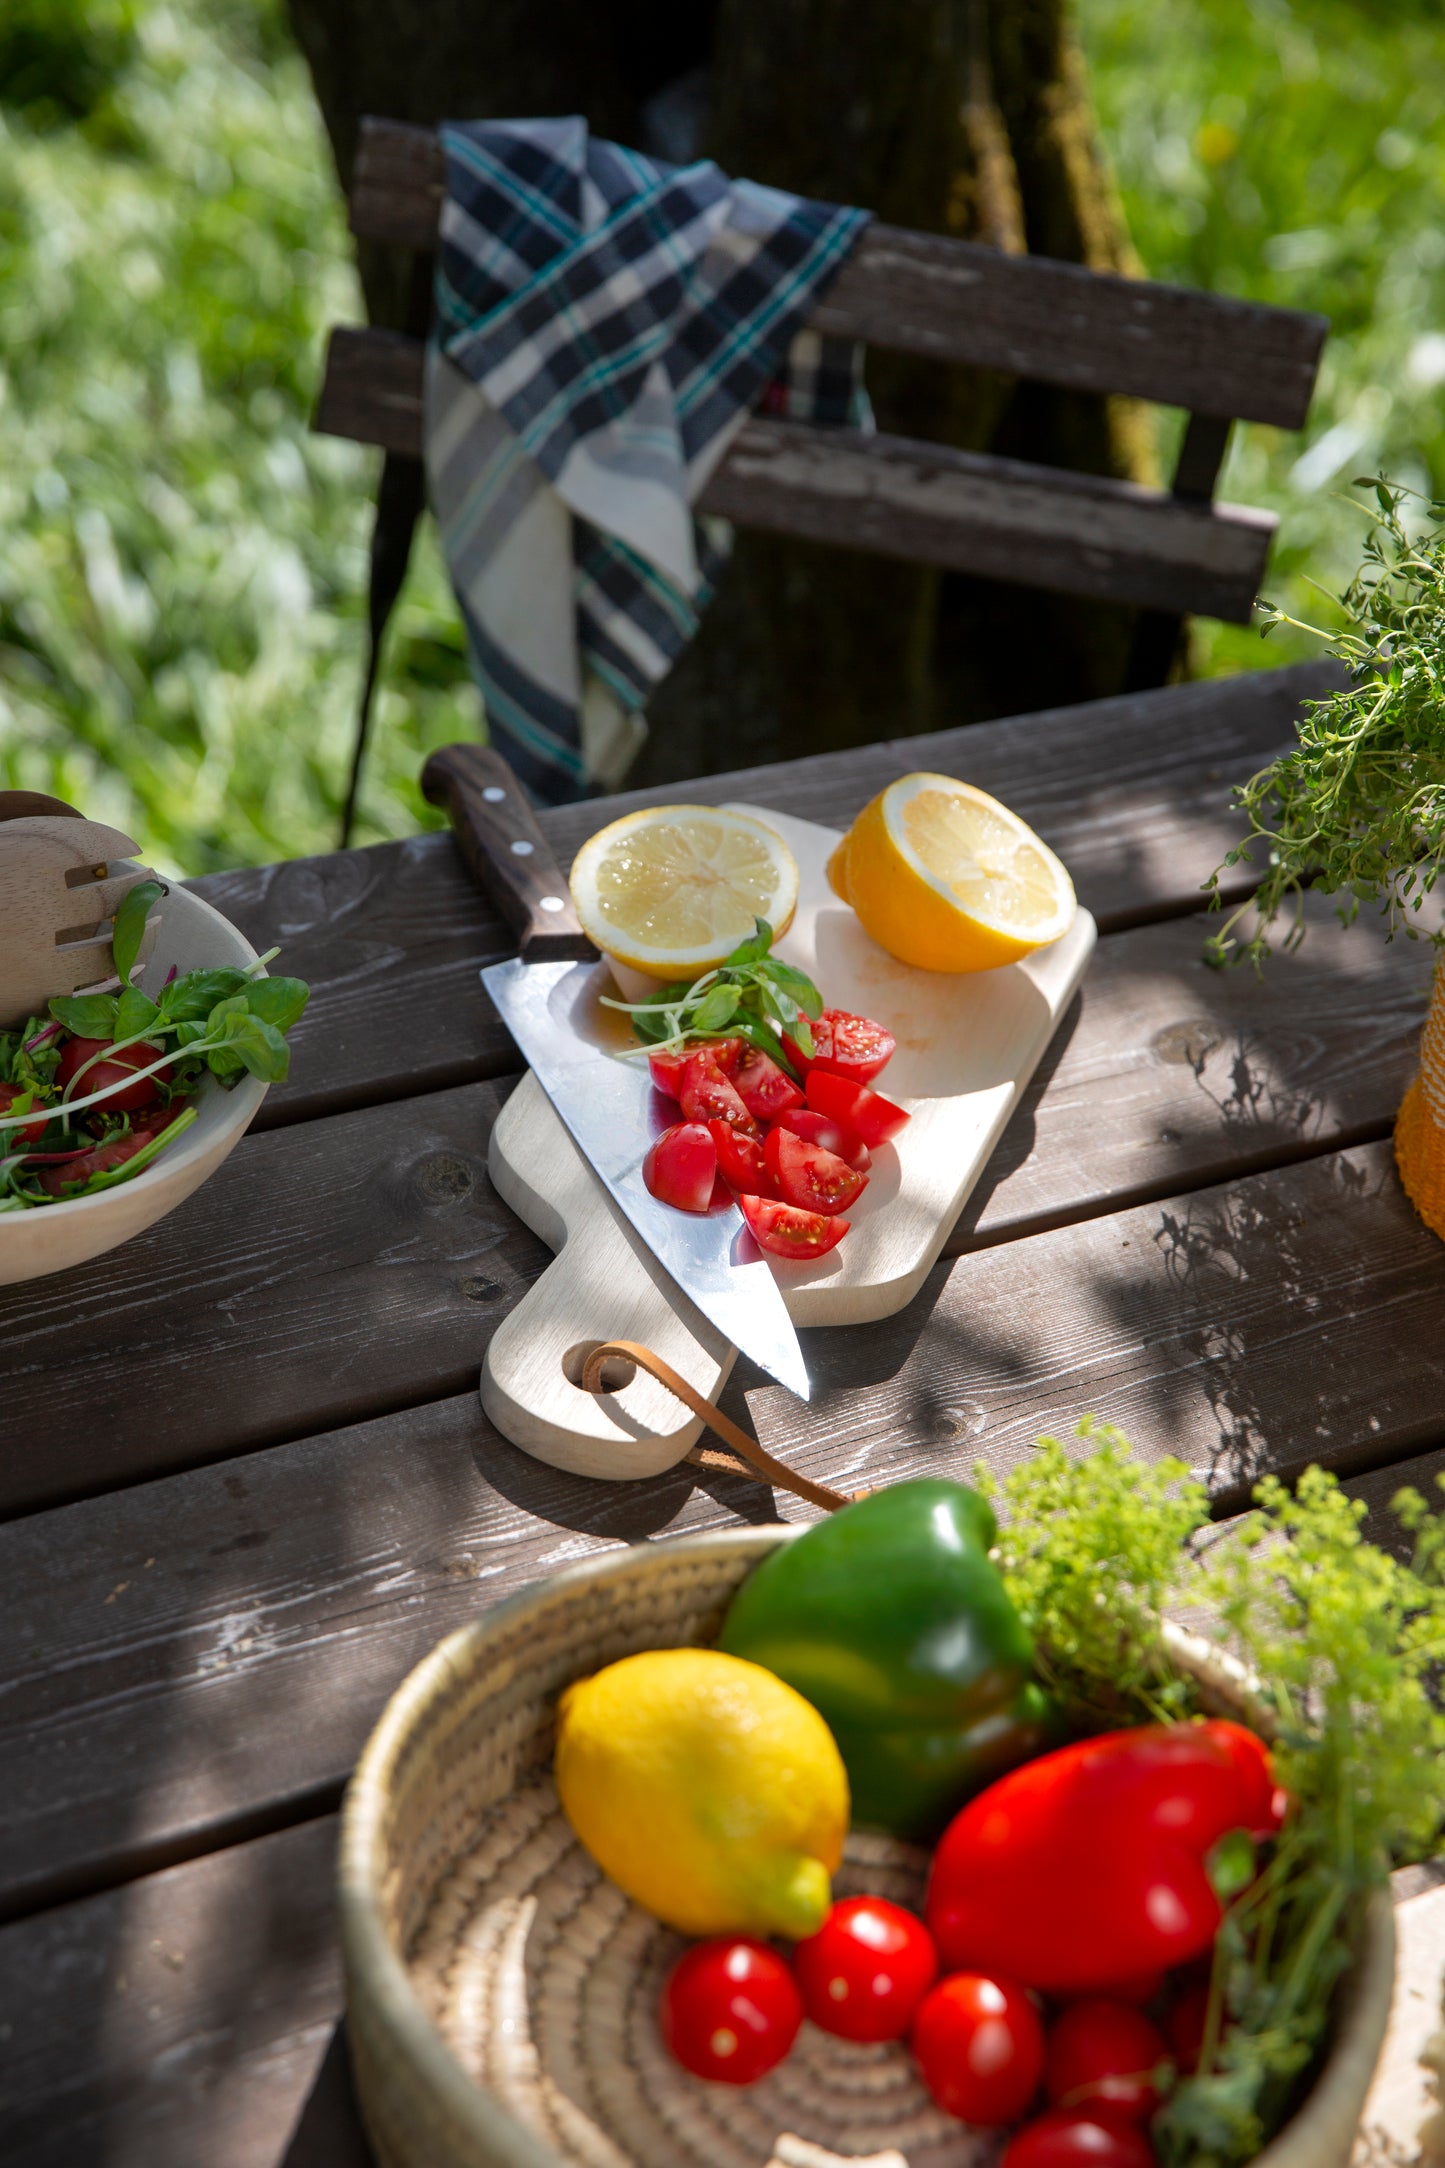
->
[0,663,1445,2168]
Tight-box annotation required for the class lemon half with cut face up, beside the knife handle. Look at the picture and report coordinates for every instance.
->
[572,806,797,980]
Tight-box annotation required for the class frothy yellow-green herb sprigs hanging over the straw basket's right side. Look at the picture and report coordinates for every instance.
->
[979,1424,1445,2168]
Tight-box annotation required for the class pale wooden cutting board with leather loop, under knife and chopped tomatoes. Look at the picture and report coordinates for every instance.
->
[481,806,1096,1479]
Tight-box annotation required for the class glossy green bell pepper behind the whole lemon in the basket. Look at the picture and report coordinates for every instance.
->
[717,1479,1053,1841]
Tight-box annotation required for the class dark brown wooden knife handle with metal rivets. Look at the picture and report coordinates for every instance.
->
[422,746,598,963]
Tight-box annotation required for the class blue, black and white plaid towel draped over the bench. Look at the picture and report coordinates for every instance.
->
[425,119,871,802]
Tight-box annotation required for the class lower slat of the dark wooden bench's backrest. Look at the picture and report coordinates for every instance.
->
[316,330,1278,624]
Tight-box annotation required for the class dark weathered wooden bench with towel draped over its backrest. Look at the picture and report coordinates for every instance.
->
[316,119,1328,819]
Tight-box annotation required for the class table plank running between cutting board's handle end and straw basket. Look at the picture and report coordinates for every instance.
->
[0,1147,1445,1912]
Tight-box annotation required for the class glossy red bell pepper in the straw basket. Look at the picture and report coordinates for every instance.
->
[927,1721,1280,1995]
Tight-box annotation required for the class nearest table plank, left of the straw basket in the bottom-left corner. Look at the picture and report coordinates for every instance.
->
[0,1819,342,2168]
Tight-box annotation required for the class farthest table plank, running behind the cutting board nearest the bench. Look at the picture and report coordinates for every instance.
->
[195,663,1360,1127]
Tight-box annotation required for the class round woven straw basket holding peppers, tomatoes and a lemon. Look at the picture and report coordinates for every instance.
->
[340,1528,1395,2168]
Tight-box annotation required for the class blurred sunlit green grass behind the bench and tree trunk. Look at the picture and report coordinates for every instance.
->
[0,0,1445,872]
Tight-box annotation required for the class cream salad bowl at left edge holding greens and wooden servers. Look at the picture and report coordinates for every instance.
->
[0,882,266,1286]
